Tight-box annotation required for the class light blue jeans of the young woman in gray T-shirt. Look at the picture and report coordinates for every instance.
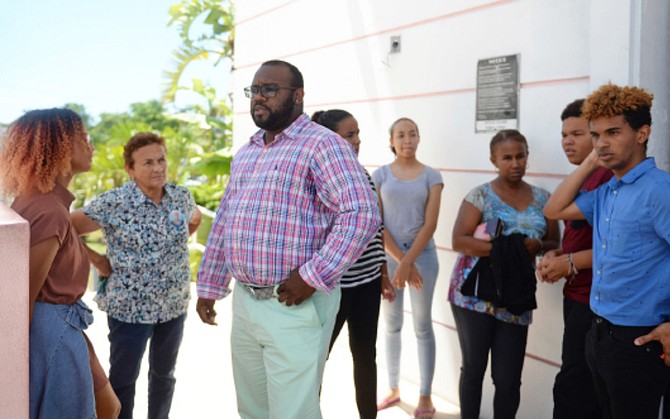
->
[382,240,439,396]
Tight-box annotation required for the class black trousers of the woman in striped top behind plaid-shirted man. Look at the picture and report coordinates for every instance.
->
[329,278,382,419]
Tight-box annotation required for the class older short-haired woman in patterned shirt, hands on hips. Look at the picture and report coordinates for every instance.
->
[72,132,201,418]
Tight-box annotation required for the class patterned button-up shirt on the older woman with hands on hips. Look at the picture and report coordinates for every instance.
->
[83,181,195,324]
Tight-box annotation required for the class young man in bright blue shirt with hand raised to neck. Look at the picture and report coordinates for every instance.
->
[544,84,670,419]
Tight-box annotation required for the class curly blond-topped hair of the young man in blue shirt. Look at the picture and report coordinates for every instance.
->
[582,83,654,130]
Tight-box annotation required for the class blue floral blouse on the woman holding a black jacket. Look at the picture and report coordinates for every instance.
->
[449,183,549,325]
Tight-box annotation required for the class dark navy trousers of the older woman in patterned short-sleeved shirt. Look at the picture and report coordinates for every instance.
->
[107,314,186,419]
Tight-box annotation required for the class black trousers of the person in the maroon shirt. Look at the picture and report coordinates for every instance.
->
[554,299,602,419]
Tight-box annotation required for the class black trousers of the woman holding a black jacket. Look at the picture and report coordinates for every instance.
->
[451,304,528,419]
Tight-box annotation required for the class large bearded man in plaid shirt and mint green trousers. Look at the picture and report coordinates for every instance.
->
[197,61,381,419]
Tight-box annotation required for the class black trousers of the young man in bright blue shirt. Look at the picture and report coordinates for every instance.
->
[586,317,670,419]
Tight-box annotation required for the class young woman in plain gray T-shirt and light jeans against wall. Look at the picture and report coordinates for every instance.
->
[372,118,443,419]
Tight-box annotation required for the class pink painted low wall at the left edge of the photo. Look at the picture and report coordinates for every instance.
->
[0,202,30,419]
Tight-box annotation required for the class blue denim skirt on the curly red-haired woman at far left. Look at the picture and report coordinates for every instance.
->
[30,300,95,419]
